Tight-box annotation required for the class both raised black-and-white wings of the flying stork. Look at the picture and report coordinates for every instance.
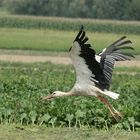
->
[69,26,133,90]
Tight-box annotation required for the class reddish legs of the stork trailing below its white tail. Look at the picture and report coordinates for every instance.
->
[97,96,122,121]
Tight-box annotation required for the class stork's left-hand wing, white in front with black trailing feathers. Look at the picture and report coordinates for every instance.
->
[69,27,105,89]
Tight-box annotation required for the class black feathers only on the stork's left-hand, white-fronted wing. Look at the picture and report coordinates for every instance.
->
[74,27,105,90]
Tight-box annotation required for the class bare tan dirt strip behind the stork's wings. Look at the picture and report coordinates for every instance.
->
[0,54,140,67]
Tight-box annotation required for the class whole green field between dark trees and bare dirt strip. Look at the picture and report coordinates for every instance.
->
[0,15,140,54]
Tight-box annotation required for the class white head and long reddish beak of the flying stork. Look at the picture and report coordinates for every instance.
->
[42,91,66,101]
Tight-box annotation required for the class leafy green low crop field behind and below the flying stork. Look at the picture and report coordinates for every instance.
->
[0,62,140,131]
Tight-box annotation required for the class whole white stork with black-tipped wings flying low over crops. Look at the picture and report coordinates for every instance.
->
[42,26,134,120]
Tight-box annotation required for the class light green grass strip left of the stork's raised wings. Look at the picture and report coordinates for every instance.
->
[0,28,72,51]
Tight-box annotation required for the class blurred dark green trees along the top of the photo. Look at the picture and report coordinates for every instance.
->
[0,0,140,20]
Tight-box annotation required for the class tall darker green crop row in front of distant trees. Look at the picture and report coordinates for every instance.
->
[0,15,140,34]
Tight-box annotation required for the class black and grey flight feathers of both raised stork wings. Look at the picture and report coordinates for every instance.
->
[71,26,134,90]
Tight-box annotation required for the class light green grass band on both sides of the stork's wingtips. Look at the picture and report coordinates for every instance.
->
[0,28,140,54]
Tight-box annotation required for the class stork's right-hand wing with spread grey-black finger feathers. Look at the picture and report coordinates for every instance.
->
[97,36,134,89]
